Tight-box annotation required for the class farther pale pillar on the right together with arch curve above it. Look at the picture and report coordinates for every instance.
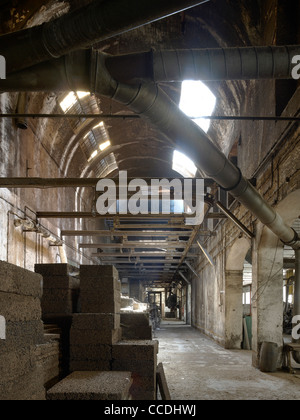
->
[225,237,251,349]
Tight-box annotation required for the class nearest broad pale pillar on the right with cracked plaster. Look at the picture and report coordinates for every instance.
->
[252,232,283,367]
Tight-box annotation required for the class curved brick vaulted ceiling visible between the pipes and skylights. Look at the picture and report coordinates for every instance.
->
[0,0,272,177]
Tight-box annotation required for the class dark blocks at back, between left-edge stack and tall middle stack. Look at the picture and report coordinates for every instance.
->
[35,264,79,319]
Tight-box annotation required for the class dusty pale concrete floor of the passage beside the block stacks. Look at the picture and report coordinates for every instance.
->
[155,321,300,400]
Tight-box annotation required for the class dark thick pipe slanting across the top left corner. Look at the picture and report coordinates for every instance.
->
[0,0,208,74]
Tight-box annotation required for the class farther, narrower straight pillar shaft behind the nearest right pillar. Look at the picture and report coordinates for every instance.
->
[225,270,243,349]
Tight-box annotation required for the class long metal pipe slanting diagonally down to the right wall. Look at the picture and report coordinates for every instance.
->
[95,61,300,248]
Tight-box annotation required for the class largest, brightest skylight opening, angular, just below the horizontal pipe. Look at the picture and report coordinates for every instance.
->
[179,80,217,133]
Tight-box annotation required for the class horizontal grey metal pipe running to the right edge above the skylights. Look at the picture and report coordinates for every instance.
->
[107,45,300,83]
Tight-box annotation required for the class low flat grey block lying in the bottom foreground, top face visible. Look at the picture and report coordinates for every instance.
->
[47,372,132,401]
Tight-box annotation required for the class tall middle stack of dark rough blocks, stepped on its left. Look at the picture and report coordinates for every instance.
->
[70,266,122,372]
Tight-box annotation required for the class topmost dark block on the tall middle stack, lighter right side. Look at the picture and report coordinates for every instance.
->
[80,265,121,314]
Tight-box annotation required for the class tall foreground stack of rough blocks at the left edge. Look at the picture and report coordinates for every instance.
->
[0,262,45,400]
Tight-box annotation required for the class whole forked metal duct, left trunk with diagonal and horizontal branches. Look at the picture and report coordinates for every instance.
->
[0,46,300,249]
